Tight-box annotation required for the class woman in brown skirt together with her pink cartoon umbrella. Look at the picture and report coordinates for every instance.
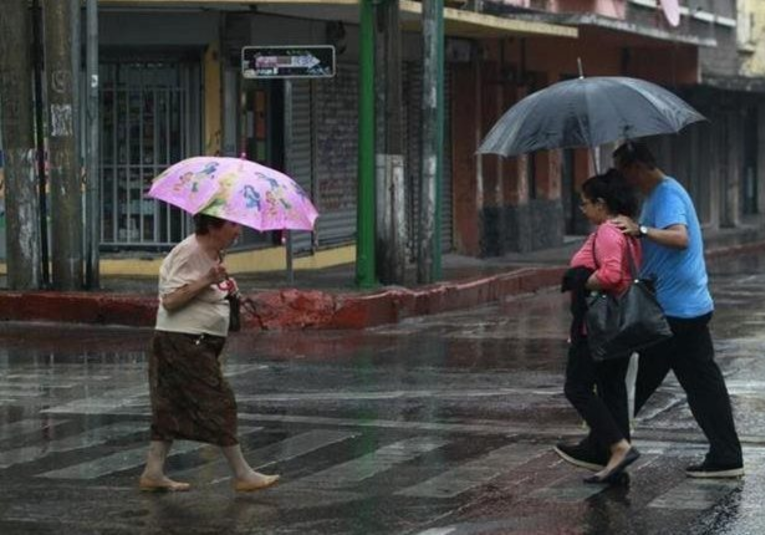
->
[139,157,318,492]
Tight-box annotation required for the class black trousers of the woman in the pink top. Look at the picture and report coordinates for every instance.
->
[564,338,630,455]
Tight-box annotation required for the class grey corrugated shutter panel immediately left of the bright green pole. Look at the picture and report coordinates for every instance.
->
[313,64,359,247]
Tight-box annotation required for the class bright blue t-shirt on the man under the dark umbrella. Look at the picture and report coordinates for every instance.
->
[640,177,714,318]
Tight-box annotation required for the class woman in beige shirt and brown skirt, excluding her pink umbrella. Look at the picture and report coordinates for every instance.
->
[138,215,279,492]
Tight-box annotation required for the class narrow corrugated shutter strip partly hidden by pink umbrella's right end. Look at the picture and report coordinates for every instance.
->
[287,80,313,253]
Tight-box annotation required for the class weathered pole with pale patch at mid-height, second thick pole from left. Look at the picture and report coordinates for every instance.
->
[43,0,83,290]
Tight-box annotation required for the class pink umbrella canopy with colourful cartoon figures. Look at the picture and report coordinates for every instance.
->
[148,156,318,231]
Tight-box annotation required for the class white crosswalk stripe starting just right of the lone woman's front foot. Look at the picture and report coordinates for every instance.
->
[284,437,448,489]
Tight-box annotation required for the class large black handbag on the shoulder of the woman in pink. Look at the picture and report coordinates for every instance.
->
[584,234,672,361]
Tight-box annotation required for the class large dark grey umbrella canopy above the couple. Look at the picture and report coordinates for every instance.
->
[478,76,705,156]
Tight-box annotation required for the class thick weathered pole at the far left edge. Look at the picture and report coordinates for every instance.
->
[0,0,40,290]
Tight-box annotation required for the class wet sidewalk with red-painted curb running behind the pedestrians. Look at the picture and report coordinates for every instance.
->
[0,225,765,330]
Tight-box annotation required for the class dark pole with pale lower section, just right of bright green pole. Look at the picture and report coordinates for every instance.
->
[375,0,406,284]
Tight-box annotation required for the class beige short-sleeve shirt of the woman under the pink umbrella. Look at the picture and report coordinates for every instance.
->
[156,234,230,336]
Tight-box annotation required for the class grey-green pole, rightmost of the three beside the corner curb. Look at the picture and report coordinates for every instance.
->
[417,0,444,284]
